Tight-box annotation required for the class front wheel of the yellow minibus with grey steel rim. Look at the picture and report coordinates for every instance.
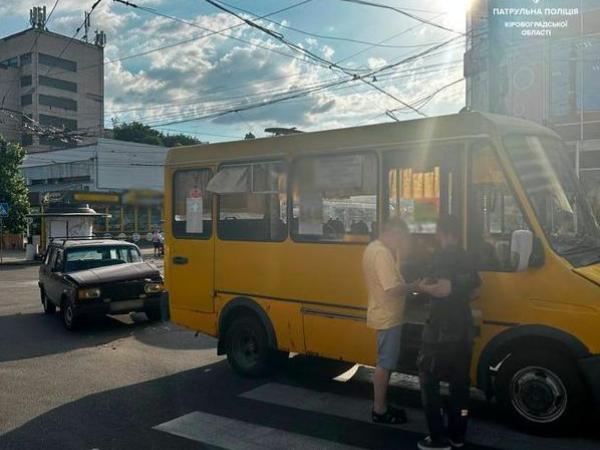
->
[495,350,588,435]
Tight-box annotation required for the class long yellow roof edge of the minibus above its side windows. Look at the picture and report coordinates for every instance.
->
[166,112,558,166]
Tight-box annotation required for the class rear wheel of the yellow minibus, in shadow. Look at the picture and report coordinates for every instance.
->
[225,315,281,378]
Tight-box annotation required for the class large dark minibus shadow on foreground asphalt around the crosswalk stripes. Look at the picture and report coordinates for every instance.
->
[0,357,600,450]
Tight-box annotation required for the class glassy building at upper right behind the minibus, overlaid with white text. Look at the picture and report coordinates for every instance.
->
[464,0,600,211]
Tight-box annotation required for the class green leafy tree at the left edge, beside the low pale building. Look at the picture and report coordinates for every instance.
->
[0,136,29,233]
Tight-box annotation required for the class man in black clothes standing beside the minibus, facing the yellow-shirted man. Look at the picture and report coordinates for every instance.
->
[417,216,481,450]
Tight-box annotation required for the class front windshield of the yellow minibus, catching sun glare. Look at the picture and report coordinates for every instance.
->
[504,135,600,266]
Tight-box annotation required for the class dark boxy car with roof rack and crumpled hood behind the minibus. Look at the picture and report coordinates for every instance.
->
[38,239,164,330]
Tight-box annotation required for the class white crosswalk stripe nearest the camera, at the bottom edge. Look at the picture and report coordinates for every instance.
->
[154,411,359,450]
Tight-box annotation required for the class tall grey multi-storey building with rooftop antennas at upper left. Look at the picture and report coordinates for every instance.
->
[0,8,105,152]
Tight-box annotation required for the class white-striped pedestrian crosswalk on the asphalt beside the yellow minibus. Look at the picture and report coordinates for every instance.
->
[154,370,584,450]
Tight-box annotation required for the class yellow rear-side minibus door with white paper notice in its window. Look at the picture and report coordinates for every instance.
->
[165,168,214,312]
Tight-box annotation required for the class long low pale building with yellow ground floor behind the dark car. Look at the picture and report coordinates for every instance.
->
[22,138,168,242]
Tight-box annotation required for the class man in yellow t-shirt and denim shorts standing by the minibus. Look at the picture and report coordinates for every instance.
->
[363,218,410,424]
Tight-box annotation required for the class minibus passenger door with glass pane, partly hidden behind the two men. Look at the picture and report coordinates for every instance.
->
[384,143,465,372]
